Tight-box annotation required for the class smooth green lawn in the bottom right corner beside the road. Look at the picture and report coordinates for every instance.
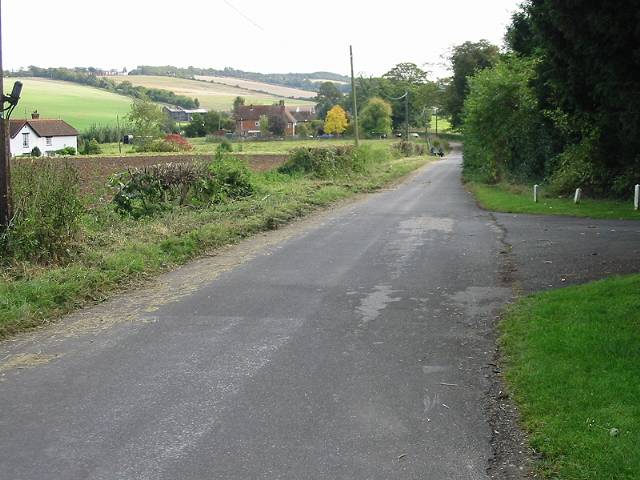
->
[500,275,640,480]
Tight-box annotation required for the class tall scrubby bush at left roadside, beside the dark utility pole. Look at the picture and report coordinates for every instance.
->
[0,160,84,262]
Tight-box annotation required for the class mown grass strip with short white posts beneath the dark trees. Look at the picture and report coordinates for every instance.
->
[467,182,640,220]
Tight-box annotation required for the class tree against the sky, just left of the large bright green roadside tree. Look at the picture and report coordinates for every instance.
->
[445,40,500,127]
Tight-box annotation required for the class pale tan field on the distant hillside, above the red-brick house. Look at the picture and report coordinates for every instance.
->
[109,75,312,111]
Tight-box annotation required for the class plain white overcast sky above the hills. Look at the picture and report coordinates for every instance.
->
[2,0,521,78]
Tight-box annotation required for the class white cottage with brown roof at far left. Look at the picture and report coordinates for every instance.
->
[9,118,78,156]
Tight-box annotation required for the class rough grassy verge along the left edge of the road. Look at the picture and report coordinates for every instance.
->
[0,150,428,337]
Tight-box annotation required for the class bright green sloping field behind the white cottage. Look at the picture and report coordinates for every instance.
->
[5,78,132,131]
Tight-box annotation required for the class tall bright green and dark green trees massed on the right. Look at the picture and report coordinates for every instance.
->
[458,0,640,196]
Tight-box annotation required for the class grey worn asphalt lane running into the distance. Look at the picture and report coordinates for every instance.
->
[0,153,637,480]
